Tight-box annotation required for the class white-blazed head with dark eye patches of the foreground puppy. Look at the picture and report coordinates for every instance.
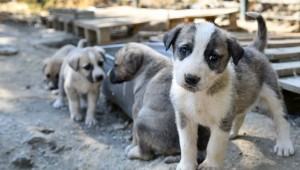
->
[164,22,244,92]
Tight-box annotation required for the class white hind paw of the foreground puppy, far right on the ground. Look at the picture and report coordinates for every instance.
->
[274,139,295,157]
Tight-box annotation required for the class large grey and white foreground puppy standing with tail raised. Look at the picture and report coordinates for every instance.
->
[164,13,294,170]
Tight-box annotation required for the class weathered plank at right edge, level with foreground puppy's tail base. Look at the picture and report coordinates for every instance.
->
[265,46,300,60]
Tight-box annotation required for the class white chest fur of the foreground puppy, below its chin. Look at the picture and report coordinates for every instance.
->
[171,73,233,127]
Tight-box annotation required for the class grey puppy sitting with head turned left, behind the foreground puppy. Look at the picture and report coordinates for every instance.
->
[108,43,180,160]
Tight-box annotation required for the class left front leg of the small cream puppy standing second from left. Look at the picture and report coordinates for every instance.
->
[66,88,82,121]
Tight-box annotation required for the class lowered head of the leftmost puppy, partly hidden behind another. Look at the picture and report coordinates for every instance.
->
[42,57,63,90]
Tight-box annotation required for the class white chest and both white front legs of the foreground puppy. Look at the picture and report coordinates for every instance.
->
[171,64,235,169]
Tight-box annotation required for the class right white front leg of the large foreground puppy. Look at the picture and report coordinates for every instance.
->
[198,125,229,169]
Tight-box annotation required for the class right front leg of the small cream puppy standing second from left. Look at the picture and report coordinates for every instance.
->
[85,90,99,126]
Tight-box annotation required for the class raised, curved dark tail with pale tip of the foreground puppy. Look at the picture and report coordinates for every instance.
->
[246,12,268,52]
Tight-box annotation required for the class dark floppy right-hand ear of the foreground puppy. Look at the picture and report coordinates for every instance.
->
[227,36,245,65]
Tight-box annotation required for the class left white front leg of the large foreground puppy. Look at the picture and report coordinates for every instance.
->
[176,112,198,170]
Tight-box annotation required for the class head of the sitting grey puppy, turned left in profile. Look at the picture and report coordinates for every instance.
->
[108,43,144,83]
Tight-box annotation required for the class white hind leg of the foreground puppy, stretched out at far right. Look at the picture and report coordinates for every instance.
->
[260,85,295,156]
